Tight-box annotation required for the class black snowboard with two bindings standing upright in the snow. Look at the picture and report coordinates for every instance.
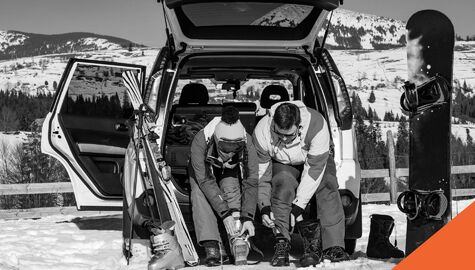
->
[398,10,455,256]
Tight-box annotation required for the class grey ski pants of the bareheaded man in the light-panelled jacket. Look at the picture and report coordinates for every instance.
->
[271,155,345,249]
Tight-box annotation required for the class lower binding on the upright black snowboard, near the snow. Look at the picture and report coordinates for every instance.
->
[397,190,448,221]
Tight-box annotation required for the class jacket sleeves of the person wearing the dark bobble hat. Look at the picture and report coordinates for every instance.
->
[191,117,258,220]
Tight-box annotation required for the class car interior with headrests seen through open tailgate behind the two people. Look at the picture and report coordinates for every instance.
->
[164,54,324,192]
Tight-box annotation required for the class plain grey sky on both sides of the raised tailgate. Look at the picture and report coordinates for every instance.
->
[0,0,475,47]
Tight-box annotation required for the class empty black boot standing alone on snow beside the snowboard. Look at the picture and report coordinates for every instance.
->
[366,214,404,259]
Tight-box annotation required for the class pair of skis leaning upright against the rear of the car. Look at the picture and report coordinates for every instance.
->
[123,71,199,266]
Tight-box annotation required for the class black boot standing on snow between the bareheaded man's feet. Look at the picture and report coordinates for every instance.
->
[297,221,322,267]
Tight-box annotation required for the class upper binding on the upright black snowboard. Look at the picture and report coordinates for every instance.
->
[400,74,450,114]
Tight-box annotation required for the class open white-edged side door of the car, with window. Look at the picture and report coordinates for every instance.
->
[41,58,145,210]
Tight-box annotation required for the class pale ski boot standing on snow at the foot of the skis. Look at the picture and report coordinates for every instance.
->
[148,221,185,270]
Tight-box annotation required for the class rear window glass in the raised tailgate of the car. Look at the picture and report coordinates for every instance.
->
[174,1,322,40]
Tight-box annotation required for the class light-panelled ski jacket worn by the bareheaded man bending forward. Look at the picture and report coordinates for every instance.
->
[253,101,330,209]
